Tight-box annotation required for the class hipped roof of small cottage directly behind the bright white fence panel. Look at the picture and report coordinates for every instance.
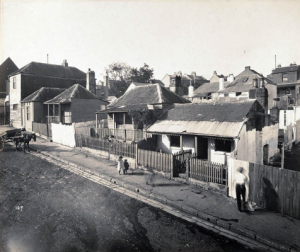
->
[45,84,107,104]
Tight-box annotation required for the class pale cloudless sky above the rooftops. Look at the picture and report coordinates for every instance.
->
[0,0,300,79]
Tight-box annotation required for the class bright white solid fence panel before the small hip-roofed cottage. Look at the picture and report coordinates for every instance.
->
[51,123,76,147]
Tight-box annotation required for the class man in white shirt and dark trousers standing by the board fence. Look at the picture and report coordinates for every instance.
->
[235,166,248,212]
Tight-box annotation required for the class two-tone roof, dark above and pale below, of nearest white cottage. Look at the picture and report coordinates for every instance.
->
[147,101,257,138]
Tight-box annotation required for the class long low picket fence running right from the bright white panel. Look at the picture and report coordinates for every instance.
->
[75,134,137,158]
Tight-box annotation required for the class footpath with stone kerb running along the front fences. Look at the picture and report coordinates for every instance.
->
[30,137,300,251]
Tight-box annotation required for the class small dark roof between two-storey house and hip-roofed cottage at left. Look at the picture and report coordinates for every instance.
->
[21,87,66,102]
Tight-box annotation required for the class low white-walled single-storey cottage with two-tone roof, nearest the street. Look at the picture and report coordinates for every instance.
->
[146,101,278,164]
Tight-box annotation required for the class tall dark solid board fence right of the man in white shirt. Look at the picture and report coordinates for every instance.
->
[249,163,300,219]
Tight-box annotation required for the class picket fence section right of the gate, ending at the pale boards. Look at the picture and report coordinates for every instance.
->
[189,158,228,185]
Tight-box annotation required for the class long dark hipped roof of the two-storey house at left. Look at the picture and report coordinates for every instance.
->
[9,62,86,79]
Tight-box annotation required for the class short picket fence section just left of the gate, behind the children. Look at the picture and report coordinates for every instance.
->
[138,149,173,172]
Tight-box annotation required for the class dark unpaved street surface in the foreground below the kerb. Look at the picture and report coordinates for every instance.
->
[0,145,253,252]
